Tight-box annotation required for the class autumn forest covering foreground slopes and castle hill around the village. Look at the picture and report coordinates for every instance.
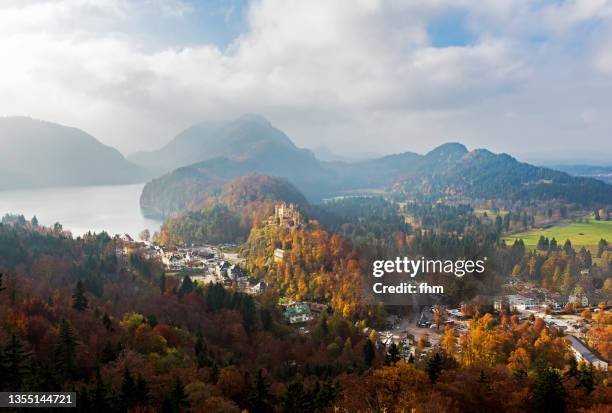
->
[0,187,612,412]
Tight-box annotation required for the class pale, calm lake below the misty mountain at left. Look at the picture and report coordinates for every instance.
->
[0,184,161,239]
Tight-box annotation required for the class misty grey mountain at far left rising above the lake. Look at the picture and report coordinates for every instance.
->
[0,117,147,189]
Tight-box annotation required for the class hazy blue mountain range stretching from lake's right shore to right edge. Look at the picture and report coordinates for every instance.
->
[141,115,612,216]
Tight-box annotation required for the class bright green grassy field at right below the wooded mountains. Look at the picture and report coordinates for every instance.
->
[504,218,612,248]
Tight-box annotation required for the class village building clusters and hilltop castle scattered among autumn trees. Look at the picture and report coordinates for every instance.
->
[115,203,608,369]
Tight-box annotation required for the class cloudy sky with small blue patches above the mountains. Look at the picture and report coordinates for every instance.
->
[0,0,612,164]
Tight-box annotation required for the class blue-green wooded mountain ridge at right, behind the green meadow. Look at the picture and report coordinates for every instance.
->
[396,144,612,206]
